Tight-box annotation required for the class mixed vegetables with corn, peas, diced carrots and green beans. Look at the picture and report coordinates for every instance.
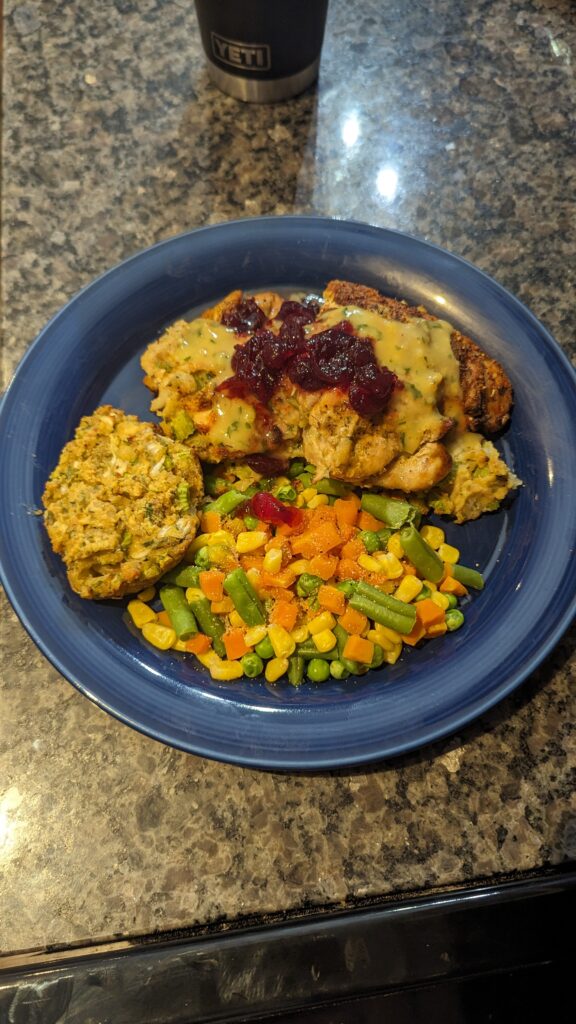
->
[128,459,484,686]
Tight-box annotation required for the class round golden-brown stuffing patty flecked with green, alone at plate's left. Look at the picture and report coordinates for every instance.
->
[42,406,203,599]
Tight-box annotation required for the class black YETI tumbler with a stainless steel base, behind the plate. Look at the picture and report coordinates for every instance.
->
[195,0,328,103]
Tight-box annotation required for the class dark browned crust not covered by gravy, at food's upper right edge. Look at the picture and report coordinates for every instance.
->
[324,281,513,433]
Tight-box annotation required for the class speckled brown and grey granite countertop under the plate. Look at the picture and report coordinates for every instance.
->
[0,0,576,954]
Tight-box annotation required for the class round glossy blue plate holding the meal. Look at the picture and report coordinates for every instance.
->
[0,217,576,769]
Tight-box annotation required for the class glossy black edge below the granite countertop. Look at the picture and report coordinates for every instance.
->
[0,865,576,1024]
